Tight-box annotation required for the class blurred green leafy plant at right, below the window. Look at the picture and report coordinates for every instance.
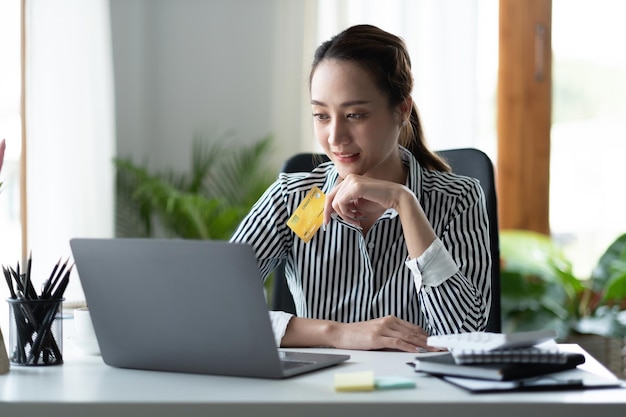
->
[500,230,626,374]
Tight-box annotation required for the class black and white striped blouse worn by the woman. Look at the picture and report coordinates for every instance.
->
[231,148,491,343]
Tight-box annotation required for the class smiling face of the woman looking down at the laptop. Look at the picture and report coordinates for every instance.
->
[311,59,411,180]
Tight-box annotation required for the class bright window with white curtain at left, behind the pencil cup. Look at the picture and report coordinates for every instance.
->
[0,0,115,302]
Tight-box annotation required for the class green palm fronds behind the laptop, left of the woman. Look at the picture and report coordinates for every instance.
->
[114,136,278,239]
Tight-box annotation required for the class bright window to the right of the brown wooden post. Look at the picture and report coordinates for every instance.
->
[550,0,626,277]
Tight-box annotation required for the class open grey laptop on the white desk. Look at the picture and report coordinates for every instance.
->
[70,238,350,378]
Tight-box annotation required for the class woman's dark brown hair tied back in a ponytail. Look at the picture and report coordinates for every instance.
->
[309,25,450,172]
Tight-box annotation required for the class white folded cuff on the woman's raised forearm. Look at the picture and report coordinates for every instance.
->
[405,238,459,291]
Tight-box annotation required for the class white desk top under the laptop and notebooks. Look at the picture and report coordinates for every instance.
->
[0,334,626,417]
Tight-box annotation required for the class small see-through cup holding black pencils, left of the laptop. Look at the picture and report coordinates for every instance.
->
[7,298,63,366]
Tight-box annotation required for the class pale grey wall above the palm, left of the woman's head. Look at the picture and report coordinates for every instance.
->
[111,0,307,172]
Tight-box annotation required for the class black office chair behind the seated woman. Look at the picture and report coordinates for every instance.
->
[272,148,502,333]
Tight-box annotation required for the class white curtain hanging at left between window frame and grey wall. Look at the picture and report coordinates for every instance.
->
[25,0,115,302]
